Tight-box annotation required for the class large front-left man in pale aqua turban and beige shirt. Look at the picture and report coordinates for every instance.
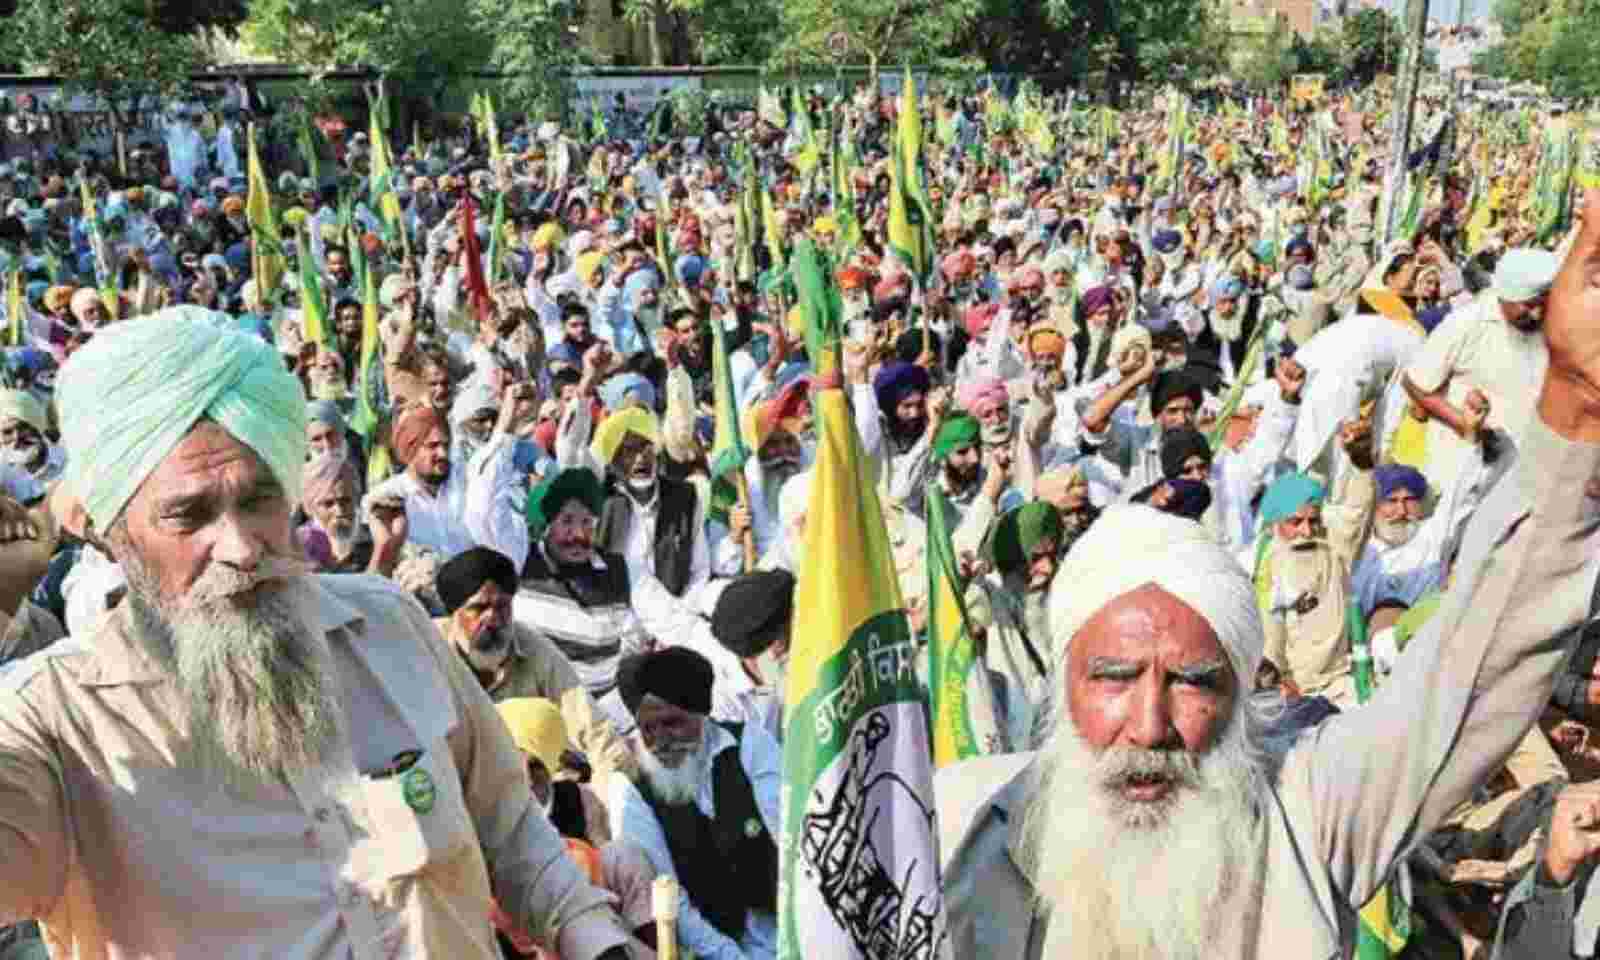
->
[0,310,627,960]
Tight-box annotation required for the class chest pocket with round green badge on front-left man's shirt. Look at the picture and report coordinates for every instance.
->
[362,741,477,882]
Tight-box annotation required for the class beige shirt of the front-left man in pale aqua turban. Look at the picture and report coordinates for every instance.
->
[0,576,626,960]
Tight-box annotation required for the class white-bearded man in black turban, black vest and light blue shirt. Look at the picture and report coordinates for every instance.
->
[606,646,782,960]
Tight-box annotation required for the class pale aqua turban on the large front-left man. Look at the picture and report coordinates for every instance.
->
[56,304,306,531]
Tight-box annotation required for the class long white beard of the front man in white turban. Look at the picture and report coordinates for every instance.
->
[1019,701,1269,960]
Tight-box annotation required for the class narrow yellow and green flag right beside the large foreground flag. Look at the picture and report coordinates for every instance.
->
[928,483,1000,766]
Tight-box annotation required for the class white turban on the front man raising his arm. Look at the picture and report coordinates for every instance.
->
[1050,504,1266,678]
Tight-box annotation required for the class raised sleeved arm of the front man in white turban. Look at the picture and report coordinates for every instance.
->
[1280,190,1600,906]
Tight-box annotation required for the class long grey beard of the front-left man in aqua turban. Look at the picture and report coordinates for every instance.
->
[117,538,341,789]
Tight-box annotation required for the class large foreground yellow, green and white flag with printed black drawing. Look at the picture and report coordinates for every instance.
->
[778,238,946,960]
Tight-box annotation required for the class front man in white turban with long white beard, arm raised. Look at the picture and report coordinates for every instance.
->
[936,190,1600,960]
